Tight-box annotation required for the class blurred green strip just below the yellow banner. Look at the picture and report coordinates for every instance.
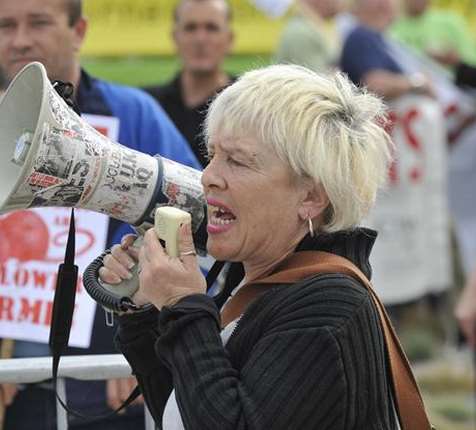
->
[82,54,271,86]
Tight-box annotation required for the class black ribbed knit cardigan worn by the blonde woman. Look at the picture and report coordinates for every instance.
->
[116,229,397,430]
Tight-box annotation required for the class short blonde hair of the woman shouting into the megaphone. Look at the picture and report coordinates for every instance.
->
[204,65,392,232]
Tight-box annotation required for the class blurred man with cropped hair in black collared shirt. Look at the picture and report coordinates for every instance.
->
[146,0,234,166]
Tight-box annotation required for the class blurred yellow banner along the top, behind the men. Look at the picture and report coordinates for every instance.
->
[82,0,476,57]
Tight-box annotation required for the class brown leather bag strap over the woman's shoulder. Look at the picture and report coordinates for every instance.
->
[221,251,433,430]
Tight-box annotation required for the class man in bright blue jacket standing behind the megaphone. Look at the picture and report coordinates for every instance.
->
[0,0,200,430]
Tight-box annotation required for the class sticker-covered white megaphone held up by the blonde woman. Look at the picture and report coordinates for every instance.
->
[0,62,207,310]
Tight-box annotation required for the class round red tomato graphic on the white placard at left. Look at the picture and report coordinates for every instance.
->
[0,210,50,263]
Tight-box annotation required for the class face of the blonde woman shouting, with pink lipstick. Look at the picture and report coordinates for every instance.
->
[202,136,308,265]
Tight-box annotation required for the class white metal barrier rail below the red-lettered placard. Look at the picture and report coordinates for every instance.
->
[0,354,155,430]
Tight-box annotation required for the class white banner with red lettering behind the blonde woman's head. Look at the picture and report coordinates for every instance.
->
[368,96,451,304]
